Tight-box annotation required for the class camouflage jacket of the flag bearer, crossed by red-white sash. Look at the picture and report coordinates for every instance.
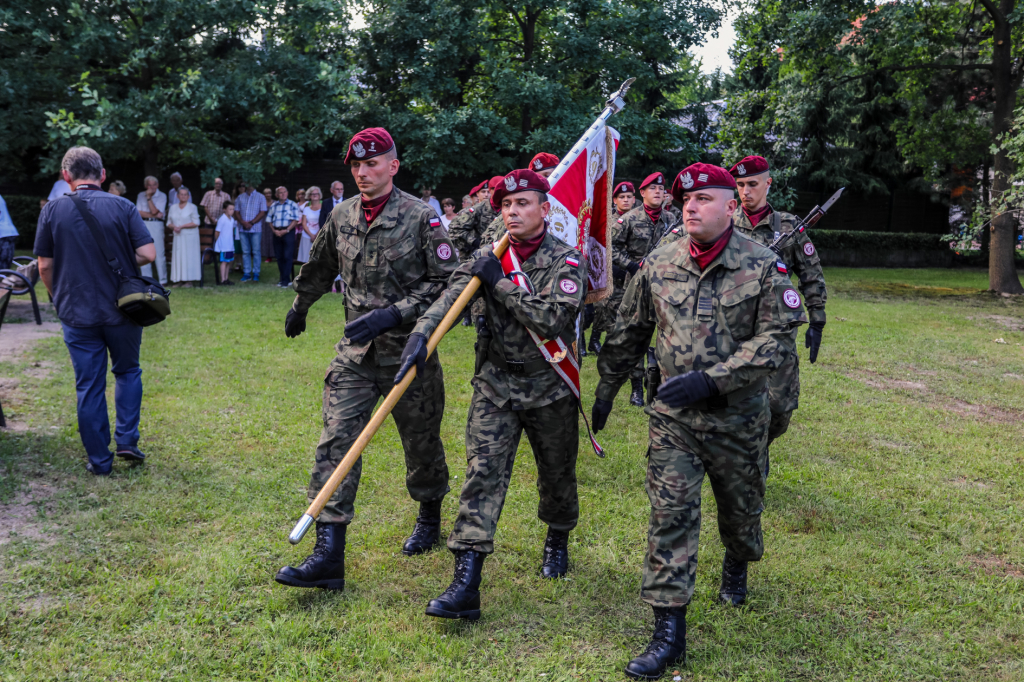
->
[413,228,587,410]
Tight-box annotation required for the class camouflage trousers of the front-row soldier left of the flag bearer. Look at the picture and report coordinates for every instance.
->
[307,353,451,524]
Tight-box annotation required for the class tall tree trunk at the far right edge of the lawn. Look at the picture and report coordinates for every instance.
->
[988,0,1024,294]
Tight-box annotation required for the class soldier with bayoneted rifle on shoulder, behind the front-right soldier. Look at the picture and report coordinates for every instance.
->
[729,157,827,462]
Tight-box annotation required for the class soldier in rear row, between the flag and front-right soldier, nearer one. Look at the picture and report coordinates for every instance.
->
[591,172,676,408]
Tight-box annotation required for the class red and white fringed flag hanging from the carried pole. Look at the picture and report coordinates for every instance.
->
[548,126,618,303]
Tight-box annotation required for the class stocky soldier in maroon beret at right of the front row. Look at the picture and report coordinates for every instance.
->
[593,164,806,679]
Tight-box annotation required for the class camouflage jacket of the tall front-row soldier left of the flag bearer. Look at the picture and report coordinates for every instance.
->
[292,187,458,366]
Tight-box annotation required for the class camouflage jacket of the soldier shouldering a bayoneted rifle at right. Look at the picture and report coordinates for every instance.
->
[732,208,828,322]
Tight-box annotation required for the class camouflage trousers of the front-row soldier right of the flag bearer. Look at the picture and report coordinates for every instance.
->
[640,413,768,606]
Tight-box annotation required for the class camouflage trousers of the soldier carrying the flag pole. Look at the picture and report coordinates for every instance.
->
[447,391,580,554]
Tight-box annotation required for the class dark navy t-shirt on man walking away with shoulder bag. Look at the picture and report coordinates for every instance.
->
[34,184,153,327]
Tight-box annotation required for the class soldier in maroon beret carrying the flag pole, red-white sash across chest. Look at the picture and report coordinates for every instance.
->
[395,170,587,620]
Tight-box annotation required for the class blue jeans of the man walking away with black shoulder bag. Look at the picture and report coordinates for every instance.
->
[63,323,142,473]
